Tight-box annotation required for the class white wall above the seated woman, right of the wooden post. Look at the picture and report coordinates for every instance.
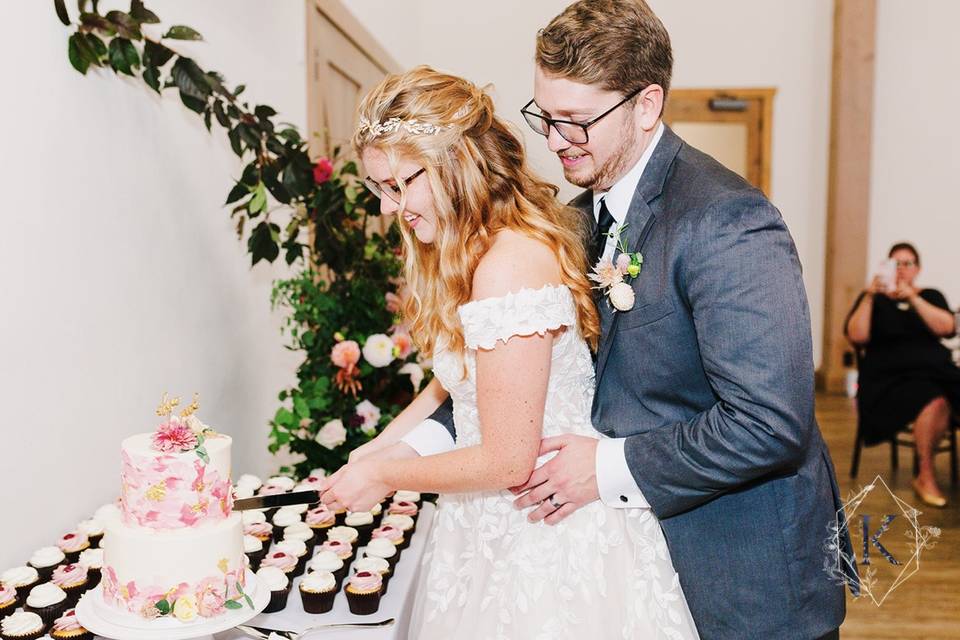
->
[868,0,960,309]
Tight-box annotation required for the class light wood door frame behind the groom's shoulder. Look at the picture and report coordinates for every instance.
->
[664,87,777,198]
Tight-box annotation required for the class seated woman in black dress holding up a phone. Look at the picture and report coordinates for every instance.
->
[846,243,960,507]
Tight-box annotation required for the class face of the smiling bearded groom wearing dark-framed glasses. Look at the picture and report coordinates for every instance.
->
[533,67,643,190]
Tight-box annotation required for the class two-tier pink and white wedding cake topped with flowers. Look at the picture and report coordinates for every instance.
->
[103,396,253,622]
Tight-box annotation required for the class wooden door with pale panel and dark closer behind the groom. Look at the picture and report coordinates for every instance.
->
[663,89,776,198]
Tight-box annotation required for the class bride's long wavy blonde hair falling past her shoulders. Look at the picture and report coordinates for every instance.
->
[352,66,600,356]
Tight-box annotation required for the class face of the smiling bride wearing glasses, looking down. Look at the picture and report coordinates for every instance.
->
[361,147,437,244]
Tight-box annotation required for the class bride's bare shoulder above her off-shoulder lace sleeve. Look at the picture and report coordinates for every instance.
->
[471,229,561,300]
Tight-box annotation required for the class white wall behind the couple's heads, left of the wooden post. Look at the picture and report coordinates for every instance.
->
[349,0,833,363]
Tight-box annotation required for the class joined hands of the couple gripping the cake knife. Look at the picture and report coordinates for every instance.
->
[319,442,417,511]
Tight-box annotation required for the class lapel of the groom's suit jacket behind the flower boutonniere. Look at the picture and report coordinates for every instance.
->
[596,125,683,385]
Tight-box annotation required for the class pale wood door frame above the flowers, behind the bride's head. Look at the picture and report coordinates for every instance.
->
[304,0,400,156]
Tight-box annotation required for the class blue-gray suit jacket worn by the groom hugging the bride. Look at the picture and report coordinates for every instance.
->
[434,128,849,640]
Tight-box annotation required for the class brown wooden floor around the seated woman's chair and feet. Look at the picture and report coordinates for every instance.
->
[817,396,960,640]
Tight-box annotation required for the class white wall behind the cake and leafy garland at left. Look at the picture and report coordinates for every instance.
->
[0,0,306,570]
